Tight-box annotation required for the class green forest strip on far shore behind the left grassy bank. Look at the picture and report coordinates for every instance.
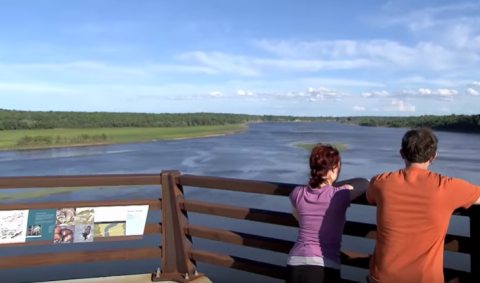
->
[0,109,333,131]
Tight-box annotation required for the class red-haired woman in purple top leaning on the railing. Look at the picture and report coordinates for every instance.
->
[285,144,369,283]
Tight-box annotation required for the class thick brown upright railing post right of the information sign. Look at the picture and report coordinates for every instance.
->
[152,171,202,283]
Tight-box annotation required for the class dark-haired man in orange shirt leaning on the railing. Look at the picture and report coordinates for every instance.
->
[366,129,480,283]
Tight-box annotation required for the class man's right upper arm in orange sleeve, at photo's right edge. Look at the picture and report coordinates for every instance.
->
[444,178,480,209]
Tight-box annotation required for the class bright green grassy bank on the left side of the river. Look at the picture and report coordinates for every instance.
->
[0,125,246,150]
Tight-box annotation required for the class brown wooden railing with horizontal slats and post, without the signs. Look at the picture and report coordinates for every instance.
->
[0,171,480,283]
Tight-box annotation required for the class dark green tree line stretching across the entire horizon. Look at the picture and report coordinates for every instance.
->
[0,110,480,133]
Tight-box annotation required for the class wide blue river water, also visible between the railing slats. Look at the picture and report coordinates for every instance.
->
[0,123,480,283]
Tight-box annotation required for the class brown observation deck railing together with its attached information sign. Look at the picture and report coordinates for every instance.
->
[0,171,480,283]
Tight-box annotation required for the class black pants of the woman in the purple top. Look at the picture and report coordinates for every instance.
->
[285,265,341,283]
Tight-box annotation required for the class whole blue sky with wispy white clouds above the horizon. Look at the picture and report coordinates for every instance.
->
[0,0,480,116]
